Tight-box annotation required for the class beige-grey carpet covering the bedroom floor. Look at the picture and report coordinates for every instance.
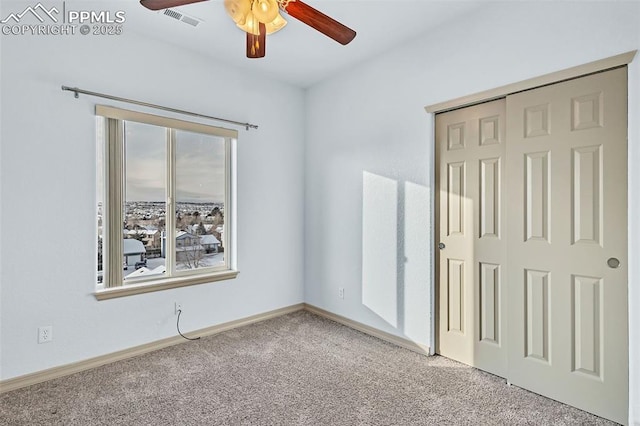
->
[0,311,613,426]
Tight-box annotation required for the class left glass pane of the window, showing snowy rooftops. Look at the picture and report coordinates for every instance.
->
[122,121,167,281]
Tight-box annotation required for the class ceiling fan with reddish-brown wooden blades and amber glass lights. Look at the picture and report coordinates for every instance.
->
[140,0,356,58]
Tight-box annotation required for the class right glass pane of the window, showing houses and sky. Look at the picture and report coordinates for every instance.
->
[175,130,226,271]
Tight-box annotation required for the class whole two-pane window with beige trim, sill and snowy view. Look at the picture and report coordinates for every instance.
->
[96,106,237,299]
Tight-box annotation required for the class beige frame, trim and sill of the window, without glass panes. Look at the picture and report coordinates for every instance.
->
[95,105,238,300]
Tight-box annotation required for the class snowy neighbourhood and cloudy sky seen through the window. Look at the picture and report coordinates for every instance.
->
[97,116,226,284]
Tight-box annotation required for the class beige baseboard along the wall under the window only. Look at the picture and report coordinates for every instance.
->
[0,303,304,393]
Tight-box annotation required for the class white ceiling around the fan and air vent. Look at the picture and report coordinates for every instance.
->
[125,0,480,87]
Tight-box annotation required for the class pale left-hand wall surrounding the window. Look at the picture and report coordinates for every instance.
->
[0,16,304,379]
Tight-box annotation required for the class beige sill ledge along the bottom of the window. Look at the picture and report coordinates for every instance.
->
[95,270,239,300]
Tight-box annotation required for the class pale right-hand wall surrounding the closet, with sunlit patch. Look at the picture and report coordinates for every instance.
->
[305,2,640,423]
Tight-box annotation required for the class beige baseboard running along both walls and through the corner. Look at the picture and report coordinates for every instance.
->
[0,303,429,393]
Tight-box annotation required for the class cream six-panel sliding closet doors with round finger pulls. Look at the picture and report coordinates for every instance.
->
[436,68,629,423]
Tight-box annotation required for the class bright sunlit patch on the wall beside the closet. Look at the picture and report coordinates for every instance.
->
[362,171,431,344]
